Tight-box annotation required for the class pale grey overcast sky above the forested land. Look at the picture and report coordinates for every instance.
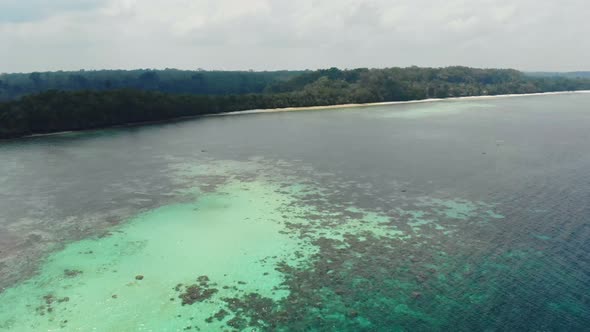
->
[0,0,590,72]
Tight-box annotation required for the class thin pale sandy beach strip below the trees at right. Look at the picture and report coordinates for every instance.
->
[215,90,590,116]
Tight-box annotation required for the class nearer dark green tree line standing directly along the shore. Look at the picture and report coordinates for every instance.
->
[0,67,590,138]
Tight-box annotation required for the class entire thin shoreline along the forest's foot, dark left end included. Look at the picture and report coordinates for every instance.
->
[8,90,590,142]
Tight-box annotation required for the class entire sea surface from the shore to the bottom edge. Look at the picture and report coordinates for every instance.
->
[0,94,590,332]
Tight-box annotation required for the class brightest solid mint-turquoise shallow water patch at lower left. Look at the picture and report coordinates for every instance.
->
[0,183,306,331]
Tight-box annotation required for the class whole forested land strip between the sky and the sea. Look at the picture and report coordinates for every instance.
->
[0,66,590,138]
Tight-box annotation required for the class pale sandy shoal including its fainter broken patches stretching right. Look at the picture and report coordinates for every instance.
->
[0,161,502,331]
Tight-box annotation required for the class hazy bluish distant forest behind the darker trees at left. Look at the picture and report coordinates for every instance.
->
[0,69,301,101]
